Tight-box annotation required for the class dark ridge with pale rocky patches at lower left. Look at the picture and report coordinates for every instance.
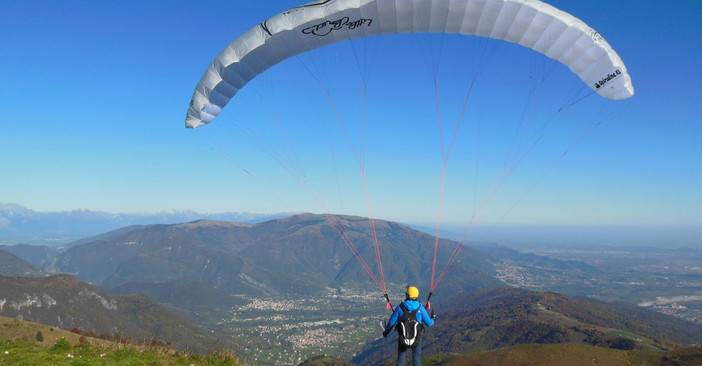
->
[0,275,233,350]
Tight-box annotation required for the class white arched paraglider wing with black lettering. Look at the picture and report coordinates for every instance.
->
[185,0,634,128]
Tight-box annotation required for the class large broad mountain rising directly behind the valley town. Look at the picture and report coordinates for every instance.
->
[44,214,502,296]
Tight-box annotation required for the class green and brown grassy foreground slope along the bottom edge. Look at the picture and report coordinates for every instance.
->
[5,317,702,366]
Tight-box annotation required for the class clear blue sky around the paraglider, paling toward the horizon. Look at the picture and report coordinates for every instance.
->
[0,0,702,244]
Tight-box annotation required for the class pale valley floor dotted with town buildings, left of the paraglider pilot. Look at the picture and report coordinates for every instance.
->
[198,289,390,365]
